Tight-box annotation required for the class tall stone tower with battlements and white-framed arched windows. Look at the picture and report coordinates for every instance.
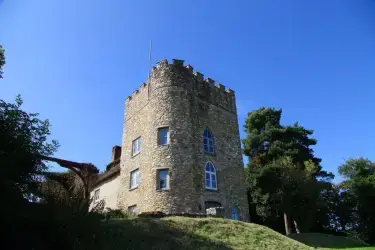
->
[118,60,249,221]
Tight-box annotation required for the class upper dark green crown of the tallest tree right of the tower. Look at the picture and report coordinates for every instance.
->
[243,107,326,177]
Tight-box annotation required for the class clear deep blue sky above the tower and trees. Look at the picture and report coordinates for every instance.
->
[0,0,375,181]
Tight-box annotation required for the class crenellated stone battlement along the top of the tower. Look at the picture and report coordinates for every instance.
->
[126,59,236,113]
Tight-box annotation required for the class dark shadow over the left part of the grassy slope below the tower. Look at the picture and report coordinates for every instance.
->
[98,218,232,250]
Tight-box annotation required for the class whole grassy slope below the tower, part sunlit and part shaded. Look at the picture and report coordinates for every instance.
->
[98,217,311,250]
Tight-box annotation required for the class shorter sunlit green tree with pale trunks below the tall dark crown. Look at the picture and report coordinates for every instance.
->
[247,157,320,234]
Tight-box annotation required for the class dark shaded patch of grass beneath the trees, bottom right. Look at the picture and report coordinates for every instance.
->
[290,233,368,248]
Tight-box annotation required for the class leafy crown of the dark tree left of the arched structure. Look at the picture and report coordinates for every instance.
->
[0,96,58,199]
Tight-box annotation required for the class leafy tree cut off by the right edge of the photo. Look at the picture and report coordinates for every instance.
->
[338,158,375,243]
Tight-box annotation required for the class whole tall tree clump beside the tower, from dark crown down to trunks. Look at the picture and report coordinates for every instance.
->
[243,107,333,234]
